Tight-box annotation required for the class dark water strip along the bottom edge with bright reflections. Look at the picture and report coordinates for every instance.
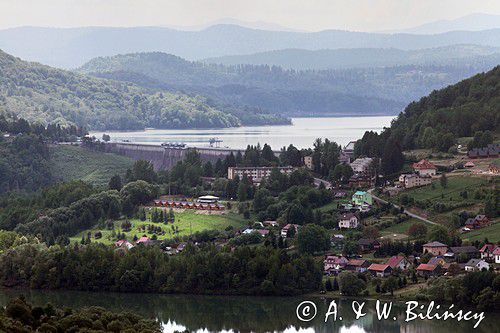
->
[0,290,500,333]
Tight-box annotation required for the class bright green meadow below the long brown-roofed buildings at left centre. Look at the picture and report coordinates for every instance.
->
[70,210,248,244]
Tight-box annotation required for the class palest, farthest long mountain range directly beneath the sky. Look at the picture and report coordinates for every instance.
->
[0,24,500,68]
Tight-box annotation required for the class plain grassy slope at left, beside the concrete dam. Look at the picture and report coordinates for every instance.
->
[50,145,134,186]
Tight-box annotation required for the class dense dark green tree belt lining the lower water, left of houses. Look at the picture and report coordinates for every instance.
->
[0,243,322,295]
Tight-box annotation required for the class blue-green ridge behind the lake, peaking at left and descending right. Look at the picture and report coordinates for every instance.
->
[79,52,403,116]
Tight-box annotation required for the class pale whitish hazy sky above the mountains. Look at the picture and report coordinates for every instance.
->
[0,0,500,31]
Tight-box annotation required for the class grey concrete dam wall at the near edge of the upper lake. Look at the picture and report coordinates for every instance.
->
[105,142,280,170]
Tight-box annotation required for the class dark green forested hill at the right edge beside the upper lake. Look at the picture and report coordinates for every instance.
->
[391,66,500,150]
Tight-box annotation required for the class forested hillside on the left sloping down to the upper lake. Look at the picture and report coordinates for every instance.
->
[0,51,286,130]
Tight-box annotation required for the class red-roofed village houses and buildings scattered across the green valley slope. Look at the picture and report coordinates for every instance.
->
[84,137,500,298]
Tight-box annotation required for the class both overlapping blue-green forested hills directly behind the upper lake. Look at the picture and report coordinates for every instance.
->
[80,52,491,116]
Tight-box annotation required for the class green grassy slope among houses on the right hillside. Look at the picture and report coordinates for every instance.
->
[401,176,486,201]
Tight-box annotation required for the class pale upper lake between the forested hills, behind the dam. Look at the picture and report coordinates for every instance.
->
[91,117,394,150]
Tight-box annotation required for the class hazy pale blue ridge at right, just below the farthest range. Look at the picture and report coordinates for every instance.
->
[203,45,500,70]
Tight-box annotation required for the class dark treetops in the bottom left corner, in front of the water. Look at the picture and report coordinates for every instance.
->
[0,297,162,333]
